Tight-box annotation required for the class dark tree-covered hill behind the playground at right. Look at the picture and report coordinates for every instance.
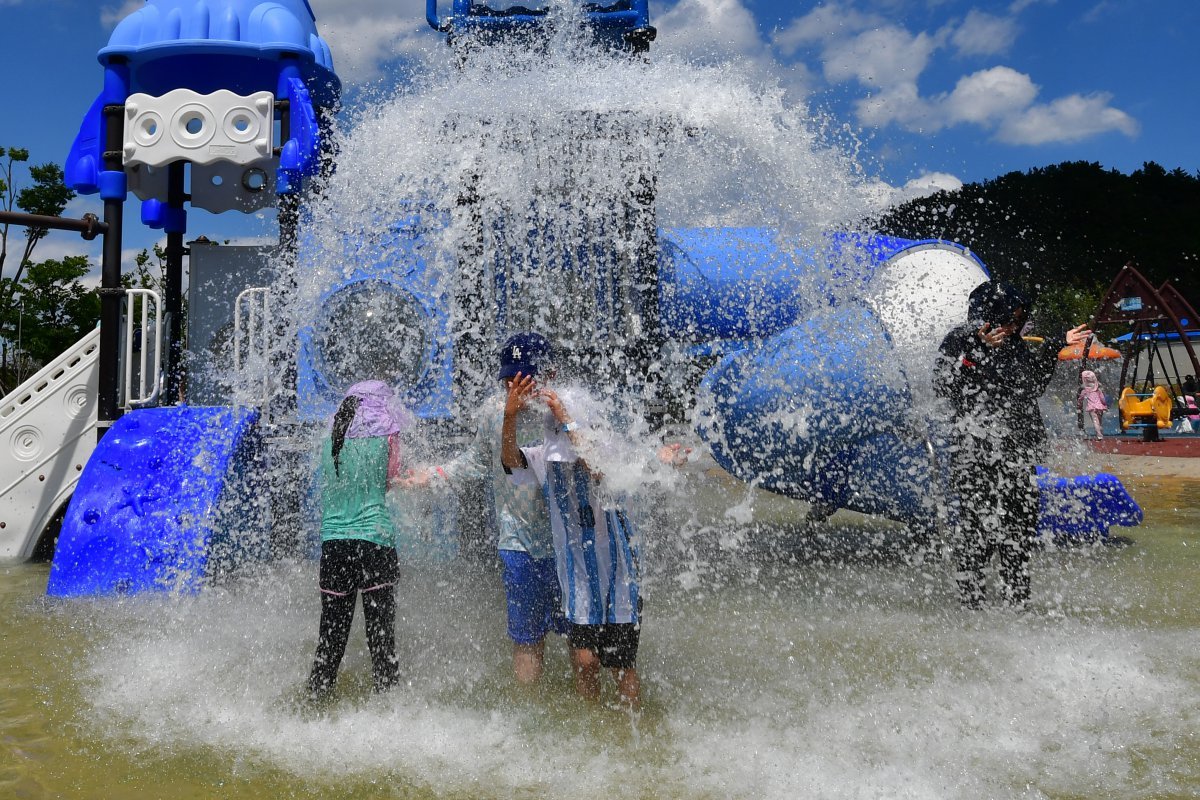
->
[877,161,1200,326]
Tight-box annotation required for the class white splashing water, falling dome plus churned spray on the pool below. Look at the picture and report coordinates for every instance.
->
[16,9,1200,798]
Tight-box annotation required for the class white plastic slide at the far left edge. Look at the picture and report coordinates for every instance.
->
[0,327,100,560]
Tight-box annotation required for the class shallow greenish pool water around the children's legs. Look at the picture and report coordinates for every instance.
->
[0,475,1200,798]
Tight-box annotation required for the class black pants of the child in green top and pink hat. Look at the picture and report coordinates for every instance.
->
[308,539,400,696]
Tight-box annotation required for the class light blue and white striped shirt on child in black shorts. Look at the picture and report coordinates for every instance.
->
[512,440,641,625]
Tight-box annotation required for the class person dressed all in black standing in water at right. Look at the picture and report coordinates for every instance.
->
[934,281,1091,607]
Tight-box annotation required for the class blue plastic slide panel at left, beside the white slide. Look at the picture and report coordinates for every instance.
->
[46,405,270,597]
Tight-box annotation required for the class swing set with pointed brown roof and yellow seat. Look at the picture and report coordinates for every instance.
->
[1080,264,1200,441]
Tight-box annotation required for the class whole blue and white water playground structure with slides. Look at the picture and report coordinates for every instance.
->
[0,0,1141,596]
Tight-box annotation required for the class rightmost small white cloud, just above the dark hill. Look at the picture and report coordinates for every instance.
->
[996,92,1139,145]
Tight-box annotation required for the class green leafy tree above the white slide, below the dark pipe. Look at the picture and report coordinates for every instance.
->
[6,255,100,365]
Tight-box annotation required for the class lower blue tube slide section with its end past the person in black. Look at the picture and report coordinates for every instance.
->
[697,305,1142,540]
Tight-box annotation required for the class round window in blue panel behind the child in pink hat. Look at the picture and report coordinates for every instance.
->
[313,281,427,391]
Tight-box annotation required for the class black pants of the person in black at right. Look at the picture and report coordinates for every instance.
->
[953,441,1038,607]
